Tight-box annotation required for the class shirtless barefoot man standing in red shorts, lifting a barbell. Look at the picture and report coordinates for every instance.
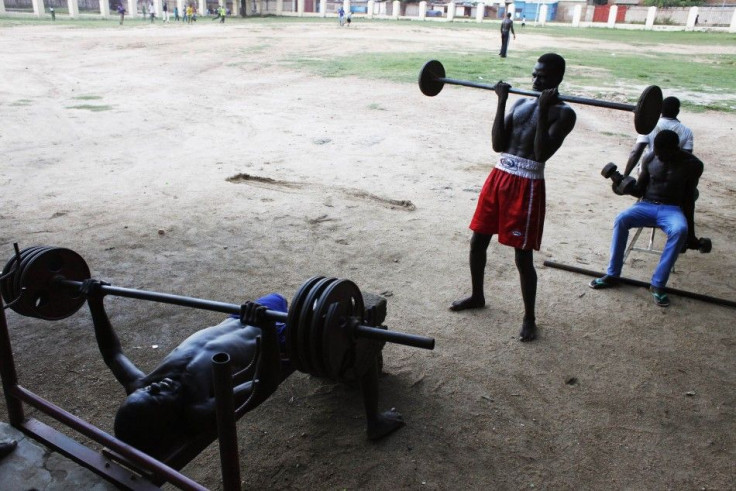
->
[450,53,576,341]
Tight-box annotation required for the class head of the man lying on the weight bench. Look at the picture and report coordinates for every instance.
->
[115,378,183,454]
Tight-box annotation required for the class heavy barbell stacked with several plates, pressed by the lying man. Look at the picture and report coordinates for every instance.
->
[0,246,434,381]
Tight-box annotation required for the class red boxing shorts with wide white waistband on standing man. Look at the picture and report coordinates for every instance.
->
[470,153,546,251]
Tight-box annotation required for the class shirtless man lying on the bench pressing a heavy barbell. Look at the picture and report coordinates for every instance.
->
[81,280,404,458]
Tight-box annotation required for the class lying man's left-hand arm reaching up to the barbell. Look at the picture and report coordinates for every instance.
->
[81,280,145,394]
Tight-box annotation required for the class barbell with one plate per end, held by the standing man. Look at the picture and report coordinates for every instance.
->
[419,60,662,135]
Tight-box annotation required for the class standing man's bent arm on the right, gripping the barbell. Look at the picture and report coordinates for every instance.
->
[534,88,577,162]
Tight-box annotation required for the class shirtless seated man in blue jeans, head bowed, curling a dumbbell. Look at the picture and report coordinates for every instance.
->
[590,130,703,307]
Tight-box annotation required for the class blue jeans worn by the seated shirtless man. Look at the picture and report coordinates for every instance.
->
[606,201,687,288]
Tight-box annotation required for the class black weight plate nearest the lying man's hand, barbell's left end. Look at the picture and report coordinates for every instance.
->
[19,247,91,320]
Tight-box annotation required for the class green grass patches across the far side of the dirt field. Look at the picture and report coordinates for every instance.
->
[0,17,736,112]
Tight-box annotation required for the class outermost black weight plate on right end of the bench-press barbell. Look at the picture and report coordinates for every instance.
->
[320,280,365,380]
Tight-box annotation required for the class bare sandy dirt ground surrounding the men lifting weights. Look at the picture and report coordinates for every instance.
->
[0,17,736,489]
